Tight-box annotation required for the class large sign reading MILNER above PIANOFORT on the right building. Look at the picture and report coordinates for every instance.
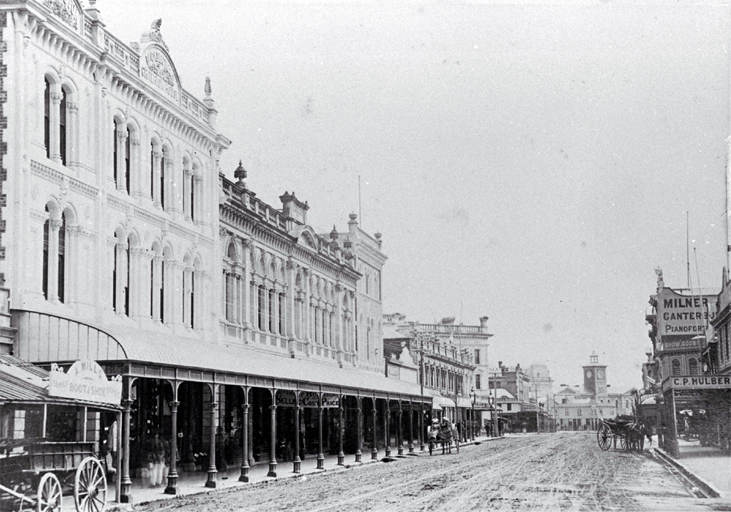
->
[657,288,716,336]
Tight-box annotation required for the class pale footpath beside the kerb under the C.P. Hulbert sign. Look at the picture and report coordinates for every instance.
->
[653,436,731,501]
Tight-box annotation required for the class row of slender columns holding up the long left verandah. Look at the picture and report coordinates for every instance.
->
[120,379,425,503]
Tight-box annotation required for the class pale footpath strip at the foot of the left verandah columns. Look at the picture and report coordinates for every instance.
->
[104,436,501,512]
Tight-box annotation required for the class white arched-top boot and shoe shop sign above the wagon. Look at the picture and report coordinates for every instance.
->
[48,360,122,405]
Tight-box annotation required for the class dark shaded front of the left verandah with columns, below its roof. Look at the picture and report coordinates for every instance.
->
[113,364,431,499]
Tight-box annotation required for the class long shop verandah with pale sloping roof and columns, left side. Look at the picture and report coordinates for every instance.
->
[16,315,431,501]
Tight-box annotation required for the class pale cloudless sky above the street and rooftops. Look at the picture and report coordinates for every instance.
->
[97,0,731,391]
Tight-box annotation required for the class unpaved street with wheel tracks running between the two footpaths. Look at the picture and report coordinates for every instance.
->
[129,432,731,512]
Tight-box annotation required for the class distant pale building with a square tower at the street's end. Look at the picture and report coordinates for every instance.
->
[554,354,634,430]
